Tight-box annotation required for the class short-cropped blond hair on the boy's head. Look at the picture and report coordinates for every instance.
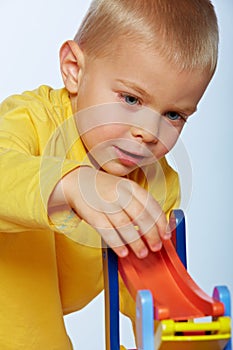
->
[74,0,219,73]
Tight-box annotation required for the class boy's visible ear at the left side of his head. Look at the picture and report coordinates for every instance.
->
[60,40,84,94]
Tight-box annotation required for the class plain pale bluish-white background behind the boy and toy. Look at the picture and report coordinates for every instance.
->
[0,0,233,350]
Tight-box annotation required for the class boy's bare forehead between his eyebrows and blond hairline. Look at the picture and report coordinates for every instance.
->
[90,40,210,109]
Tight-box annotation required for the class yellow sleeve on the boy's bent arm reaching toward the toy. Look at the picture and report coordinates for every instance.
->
[0,90,85,232]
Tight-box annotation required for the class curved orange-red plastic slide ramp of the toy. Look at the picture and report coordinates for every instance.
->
[118,240,224,321]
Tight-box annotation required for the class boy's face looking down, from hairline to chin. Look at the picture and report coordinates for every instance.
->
[69,43,210,176]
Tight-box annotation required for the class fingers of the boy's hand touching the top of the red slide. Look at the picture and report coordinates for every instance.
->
[95,190,170,259]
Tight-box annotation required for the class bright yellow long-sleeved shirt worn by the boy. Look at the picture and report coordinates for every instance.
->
[0,86,179,350]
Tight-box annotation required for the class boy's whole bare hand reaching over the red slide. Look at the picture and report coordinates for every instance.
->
[51,167,170,258]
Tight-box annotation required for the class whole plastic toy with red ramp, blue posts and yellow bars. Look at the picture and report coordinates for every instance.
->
[103,210,232,350]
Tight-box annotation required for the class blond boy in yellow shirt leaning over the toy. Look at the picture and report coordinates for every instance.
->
[0,0,218,350]
